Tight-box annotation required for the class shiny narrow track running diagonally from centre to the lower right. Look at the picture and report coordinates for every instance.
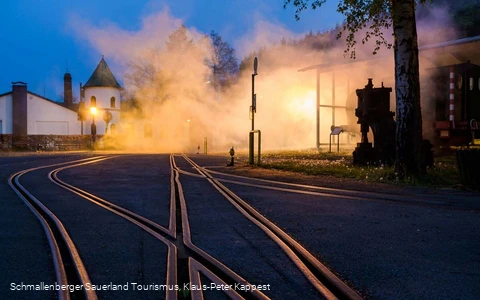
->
[177,155,362,299]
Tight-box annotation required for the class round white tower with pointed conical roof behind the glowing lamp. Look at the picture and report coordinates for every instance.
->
[82,55,122,134]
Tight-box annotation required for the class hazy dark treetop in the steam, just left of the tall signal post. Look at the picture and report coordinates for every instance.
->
[206,31,239,90]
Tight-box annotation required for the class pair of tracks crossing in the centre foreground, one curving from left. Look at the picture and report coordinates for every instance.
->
[49,155,268,299]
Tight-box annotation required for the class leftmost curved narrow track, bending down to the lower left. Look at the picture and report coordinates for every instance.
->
[8,157,105,300]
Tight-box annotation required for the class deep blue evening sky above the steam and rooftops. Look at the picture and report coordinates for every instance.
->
[0,0,342,100]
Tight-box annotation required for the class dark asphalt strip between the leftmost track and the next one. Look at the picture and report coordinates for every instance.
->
[20,162,167,299]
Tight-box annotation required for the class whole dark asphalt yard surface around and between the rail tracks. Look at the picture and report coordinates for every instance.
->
[0,154,480,299]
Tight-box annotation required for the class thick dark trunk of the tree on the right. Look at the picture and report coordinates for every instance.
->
[392,0,426,177]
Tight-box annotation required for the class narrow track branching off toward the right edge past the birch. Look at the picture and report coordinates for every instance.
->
[179,161,480,213]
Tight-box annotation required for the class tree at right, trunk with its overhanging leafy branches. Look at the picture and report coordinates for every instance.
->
[284,0,432,177]
